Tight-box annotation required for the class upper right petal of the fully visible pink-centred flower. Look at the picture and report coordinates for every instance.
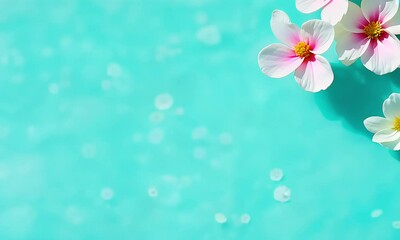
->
[301,20,335,54]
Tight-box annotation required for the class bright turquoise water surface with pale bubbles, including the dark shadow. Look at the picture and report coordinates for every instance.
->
[0,0,400,240]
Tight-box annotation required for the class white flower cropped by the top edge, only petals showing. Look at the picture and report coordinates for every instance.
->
[296,0,349,25]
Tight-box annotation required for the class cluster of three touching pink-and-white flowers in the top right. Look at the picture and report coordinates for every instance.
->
[258,0,400,92]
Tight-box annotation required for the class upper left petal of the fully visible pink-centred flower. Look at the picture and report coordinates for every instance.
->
[270,10,300,47]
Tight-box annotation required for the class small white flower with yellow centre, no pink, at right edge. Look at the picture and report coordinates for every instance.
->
[364,93,400,150]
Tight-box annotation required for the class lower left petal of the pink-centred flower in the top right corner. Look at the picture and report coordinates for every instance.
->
[336,32,370,63]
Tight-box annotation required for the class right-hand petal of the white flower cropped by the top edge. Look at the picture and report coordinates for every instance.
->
[321,0,349,25]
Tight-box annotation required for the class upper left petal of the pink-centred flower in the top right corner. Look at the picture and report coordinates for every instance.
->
[340,2,368,33]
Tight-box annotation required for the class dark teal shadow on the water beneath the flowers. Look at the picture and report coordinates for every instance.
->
[315,62,400,160]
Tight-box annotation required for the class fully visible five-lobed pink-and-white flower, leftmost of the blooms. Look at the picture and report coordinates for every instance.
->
[258,10,334,92]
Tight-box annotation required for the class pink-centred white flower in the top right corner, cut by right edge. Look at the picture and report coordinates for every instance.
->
[336,0,400,75]
